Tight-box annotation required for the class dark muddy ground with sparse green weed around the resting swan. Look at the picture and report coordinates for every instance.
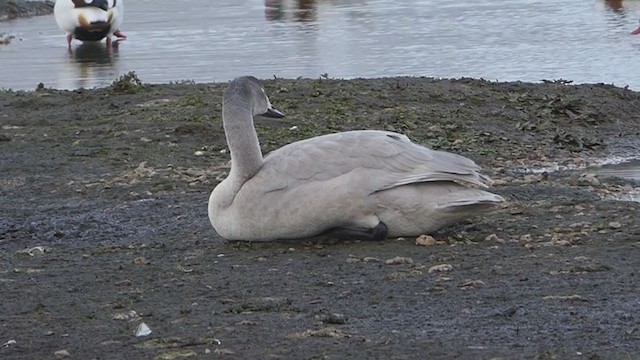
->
[0,74,640,359]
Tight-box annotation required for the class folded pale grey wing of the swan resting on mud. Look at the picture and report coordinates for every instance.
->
[254,130,491,193]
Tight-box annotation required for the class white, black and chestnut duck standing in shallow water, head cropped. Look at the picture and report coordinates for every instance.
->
[53,0,127,48]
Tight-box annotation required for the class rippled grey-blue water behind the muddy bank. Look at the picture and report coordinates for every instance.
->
[0,0,640,90]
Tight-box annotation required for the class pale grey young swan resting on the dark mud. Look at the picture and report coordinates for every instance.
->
[209,76,504,241]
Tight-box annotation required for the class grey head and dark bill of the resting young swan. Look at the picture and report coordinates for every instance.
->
[223,76,284,118]
